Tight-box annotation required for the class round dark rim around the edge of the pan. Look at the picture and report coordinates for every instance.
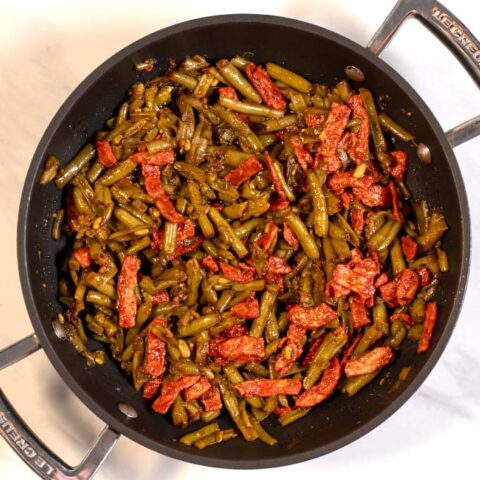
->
[17,14,471,469]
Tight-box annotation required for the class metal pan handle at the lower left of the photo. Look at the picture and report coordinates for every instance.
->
[0,335,119,480]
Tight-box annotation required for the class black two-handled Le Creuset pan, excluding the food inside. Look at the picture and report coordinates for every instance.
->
[0,0,480,479]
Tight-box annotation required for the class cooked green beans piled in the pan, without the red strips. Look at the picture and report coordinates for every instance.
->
[39,55,448,448]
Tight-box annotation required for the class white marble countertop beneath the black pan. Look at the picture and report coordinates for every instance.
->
[0,0,480,480]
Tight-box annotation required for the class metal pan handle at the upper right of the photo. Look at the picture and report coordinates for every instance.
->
[367,0,480,147]
